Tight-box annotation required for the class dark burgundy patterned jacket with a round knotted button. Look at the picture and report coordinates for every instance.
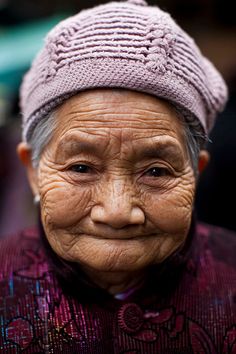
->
[0,224,236,354]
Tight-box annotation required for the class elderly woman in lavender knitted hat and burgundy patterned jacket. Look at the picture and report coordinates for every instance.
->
[0,0,236,354]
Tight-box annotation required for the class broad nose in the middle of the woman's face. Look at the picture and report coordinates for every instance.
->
[91,180,145,229]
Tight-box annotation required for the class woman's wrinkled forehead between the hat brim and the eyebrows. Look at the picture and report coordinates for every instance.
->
[53,89,184,149]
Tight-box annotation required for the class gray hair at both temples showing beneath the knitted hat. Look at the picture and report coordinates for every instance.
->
[28,106,208,176]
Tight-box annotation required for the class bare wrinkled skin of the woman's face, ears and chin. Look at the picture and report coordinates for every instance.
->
[18,89,208,294]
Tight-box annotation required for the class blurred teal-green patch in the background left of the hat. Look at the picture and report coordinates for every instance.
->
[0,14,68,126]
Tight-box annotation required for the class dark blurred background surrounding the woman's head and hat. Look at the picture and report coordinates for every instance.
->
[0,0,236,236]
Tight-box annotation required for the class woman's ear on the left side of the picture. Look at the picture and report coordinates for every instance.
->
[17,142,39,196]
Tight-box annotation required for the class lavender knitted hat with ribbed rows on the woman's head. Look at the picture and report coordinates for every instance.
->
[20,0,227,141]
